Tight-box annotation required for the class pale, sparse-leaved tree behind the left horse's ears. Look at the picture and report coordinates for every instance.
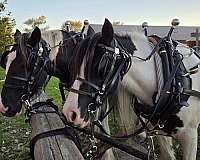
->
[24,16,49,32]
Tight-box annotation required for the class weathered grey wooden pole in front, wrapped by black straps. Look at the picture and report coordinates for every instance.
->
[30,91,84,160]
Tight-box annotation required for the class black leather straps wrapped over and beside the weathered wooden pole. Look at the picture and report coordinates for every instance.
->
[28,102,148,160]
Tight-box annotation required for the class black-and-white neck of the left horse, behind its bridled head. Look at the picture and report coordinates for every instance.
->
[43,26,95,102]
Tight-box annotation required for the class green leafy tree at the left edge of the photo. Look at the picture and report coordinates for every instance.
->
[0,0,15,53]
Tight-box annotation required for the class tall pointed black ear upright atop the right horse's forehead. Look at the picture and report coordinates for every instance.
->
[101,18,114,45]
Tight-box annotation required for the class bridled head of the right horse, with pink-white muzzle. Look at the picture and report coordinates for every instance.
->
[63,19,135,127]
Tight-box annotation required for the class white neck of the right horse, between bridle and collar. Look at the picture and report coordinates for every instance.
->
[122,32,157,105]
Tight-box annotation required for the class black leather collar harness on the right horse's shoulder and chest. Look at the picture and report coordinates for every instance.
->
[134,35,200,135]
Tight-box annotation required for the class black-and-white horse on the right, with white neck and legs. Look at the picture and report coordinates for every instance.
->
[63,19,200,160]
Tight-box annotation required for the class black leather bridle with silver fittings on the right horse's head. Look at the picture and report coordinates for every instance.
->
[70,39,131,154]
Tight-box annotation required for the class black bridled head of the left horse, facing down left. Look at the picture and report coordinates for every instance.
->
[1,27,50,117]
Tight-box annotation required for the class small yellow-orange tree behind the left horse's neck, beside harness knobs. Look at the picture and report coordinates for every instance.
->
[61,20,82,32]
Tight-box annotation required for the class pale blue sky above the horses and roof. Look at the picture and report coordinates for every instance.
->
[7,0,200,29]
